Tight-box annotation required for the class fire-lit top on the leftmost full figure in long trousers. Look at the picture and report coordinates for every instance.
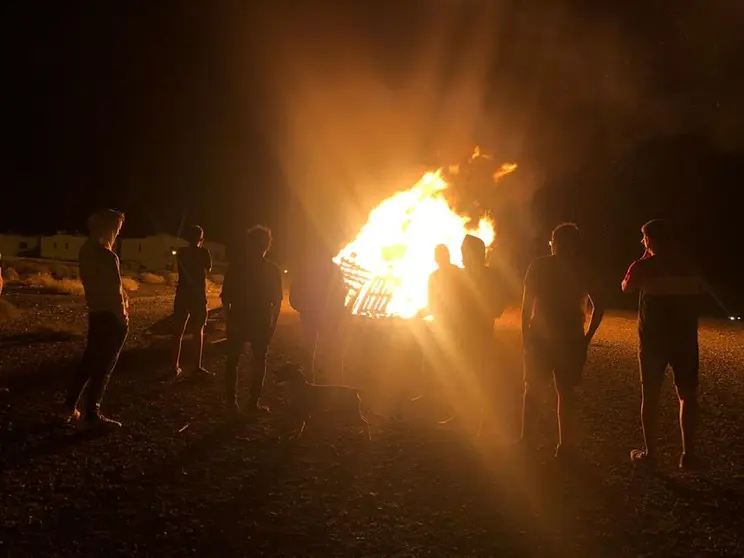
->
[78,239,129,321]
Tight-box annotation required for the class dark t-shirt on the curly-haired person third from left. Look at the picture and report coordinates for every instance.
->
[222,258,284,332]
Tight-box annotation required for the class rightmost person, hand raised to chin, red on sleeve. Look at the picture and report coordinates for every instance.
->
[622,219,704,468]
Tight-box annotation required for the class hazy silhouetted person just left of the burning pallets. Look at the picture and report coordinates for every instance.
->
[289,246,347,382]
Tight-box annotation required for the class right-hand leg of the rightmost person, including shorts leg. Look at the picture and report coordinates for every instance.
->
[671,347,700,468]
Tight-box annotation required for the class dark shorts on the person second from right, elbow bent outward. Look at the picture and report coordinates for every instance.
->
[524,338,587,390]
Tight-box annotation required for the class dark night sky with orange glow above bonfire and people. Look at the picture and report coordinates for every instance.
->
[0,0,744,266]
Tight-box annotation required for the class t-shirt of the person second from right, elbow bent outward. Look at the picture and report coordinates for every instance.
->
[524,256,596,339]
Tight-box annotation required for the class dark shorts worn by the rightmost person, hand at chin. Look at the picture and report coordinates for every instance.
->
[638,343,700,390]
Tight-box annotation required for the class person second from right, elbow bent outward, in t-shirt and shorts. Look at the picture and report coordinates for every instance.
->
[521,223,604,457]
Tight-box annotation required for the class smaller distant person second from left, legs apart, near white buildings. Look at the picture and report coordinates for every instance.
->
[173,225,212,377]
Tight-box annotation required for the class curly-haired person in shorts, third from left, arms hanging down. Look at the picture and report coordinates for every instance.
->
[222,226,283,413]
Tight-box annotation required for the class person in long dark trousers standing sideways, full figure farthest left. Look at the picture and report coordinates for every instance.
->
[63,209,129,428]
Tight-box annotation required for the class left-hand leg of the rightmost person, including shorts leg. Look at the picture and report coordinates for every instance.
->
[630,350,667,461]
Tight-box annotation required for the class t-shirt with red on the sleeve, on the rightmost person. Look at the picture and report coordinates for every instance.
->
[625,256,704,346]
